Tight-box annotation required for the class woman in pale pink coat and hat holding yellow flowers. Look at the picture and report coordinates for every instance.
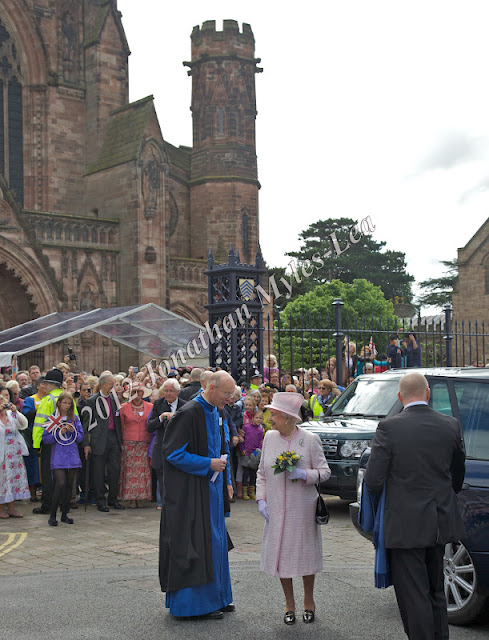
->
[256,393,331,624]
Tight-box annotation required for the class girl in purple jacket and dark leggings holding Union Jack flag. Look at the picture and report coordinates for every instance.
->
[42,391,83,527]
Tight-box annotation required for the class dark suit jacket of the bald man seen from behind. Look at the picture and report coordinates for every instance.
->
[365,405,465,549]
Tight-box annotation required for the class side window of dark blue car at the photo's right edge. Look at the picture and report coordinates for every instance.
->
[454,380,489,460]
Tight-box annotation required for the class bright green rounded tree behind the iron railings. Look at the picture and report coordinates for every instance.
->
[274,278,398,371]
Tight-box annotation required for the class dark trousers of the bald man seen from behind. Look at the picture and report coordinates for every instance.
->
[389,545,448,640]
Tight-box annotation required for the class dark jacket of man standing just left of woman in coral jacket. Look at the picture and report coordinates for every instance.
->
[80,392,122,456]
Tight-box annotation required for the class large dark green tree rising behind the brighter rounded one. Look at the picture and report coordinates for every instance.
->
[273,218,414,310]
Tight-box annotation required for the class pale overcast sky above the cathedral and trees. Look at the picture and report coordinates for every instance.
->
[118,0,489,310]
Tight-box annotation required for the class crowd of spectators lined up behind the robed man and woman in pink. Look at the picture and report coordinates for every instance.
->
[0,334,421,526]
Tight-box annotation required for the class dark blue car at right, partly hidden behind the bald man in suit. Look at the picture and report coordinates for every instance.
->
[350,369,489,624]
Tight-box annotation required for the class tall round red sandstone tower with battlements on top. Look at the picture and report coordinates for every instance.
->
[184,20,262,262]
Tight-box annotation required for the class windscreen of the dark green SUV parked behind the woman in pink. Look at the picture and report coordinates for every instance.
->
[330,376,399,418]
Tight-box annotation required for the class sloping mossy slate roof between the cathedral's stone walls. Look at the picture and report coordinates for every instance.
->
[85,96,153,175]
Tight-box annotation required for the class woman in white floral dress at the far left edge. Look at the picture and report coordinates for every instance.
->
[0,388,31,519]
